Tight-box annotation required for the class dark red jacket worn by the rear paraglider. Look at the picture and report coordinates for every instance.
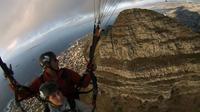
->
[12,68,91,99]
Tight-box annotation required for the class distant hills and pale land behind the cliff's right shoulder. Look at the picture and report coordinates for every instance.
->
[148,2,200,33]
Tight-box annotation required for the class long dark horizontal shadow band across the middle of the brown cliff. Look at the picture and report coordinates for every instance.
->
[101,53,200,72]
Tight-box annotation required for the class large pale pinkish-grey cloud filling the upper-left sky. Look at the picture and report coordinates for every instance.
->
[0,0,100,48]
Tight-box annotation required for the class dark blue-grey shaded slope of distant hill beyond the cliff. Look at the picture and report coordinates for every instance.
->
[175,6,200,33]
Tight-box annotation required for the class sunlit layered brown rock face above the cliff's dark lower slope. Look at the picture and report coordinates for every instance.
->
[97,9,200,100]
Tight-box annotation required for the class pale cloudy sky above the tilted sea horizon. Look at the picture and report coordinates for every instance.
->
[0,0,198,58]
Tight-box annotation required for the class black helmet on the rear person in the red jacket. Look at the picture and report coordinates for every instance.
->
[39,51,56,67]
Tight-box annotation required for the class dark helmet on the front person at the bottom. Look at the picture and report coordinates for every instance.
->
[39,81,59,100]
